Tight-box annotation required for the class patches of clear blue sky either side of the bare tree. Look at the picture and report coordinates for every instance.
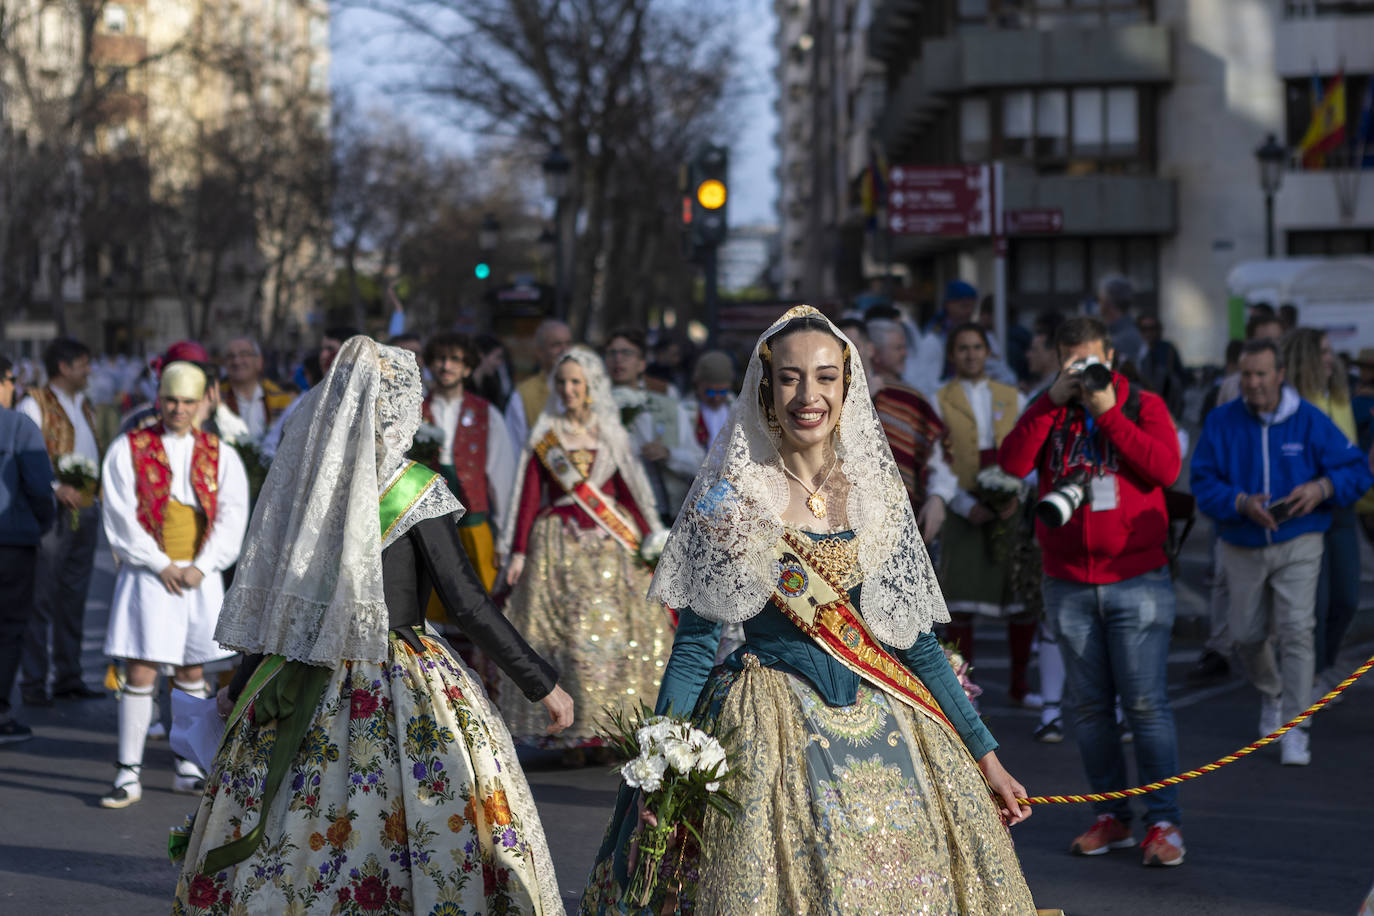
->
[331,0,778,225]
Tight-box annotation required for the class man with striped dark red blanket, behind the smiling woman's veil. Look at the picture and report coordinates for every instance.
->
[857,320,959,544]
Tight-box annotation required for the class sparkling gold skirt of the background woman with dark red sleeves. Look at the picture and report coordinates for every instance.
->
[496,515,673,747]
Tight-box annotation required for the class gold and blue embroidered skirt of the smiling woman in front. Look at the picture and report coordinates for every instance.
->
[581,666,1036,916]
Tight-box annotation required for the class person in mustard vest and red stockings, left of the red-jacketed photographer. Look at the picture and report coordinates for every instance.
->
[934,324,1041,709]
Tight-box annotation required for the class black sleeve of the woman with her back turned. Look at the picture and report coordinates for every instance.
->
[409,515,558,700]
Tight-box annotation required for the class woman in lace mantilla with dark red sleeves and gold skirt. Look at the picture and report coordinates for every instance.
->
[497,346,673,764]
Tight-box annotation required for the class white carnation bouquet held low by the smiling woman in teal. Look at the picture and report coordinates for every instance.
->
[606,705,741,906]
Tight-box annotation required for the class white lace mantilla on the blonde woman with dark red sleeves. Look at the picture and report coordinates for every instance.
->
[497,345,664,556]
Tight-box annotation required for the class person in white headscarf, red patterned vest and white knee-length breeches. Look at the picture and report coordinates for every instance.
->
[100,363,249,808]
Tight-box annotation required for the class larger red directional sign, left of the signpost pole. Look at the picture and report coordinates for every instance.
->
[888,165,992,236]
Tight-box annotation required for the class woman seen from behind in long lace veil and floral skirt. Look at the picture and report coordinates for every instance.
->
[172,336,573,916]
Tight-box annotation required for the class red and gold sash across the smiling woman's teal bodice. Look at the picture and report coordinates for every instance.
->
[772,531,963,747]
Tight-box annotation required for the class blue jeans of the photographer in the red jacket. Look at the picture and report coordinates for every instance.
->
[1041,567,1182,824]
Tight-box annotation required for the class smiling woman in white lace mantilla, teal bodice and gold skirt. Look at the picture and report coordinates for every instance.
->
[581,306,1036,916]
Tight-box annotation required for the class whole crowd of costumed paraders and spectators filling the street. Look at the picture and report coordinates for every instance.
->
[0,277,1374,912]
